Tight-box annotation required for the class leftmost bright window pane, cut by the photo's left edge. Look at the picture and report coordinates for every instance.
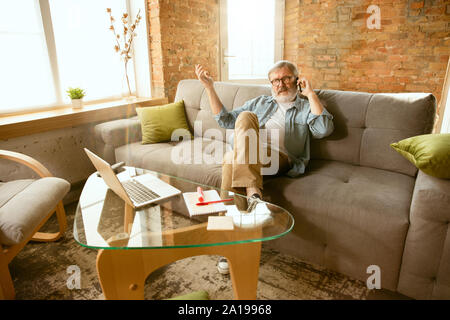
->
[0,0,56,113]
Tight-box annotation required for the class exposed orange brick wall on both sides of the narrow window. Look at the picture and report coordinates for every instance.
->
[148,0,450,112]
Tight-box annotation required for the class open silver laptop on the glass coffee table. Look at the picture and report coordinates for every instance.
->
[84,148,181,208]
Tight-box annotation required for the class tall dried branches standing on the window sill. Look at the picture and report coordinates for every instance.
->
[106,8,142,97]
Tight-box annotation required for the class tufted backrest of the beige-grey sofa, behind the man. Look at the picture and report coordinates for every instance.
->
[175,80,436,176]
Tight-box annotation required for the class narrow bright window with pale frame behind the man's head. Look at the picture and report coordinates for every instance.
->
[220,0,284,83]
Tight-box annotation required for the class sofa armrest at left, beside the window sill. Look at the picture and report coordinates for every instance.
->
[95,116,142,164]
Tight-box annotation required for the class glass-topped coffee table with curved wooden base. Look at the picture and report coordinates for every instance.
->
[73,167,294,300]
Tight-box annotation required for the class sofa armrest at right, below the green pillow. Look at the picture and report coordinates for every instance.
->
[398,171,450,299]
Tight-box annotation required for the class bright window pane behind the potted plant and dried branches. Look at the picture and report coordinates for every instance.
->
[50,0,129,100]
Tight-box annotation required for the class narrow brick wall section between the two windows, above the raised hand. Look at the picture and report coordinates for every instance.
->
[148,0,219,102]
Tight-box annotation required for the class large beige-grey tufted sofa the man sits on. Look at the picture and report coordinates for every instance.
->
[96,80,450,299]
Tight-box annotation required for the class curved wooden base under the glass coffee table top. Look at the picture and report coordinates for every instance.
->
[97,242,261,300]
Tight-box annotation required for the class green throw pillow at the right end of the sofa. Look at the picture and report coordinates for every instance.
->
[391,133,450,179]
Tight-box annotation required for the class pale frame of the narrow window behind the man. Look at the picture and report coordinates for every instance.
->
[218,0,285,84]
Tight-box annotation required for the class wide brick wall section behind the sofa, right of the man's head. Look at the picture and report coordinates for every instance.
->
[285,0,450,101]
